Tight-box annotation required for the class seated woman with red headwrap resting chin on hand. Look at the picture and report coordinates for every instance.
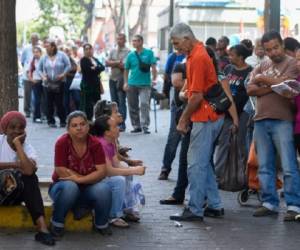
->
[0,111,55,246]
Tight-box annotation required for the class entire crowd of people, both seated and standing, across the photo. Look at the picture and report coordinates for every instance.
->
[0,23,300,245]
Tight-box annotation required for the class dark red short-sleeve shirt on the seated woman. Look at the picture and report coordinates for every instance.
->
[52,134,105,181]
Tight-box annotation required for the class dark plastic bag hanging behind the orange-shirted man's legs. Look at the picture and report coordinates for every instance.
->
[218,132,247,192]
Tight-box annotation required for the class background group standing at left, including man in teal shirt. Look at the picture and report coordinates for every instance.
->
[20,34,157,134]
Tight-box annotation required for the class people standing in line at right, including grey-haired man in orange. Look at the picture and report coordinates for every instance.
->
[158,23,300,225]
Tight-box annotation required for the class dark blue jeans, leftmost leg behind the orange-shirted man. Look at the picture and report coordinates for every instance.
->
[161,102,181,172]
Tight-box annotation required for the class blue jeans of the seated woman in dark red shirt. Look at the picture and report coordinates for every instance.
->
[49,181,111,229]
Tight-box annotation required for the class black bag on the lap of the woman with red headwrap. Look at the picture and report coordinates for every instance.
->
[0,169,24,205]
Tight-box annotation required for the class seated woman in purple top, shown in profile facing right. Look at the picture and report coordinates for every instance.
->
[92,115,145,227]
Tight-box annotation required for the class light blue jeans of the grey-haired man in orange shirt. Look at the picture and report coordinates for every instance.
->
[188,118,224,216]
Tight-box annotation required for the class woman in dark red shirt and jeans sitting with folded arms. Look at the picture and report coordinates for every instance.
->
[49,111,112,237]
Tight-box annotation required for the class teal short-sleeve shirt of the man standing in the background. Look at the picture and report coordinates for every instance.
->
[125,48,156,86]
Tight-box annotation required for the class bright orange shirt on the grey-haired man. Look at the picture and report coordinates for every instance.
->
[186,42,219,122]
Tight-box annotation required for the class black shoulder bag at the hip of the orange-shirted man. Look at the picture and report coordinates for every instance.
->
[204,83,231,114]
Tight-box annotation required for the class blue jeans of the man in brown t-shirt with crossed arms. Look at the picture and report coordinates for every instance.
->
[254,119,300,213]
